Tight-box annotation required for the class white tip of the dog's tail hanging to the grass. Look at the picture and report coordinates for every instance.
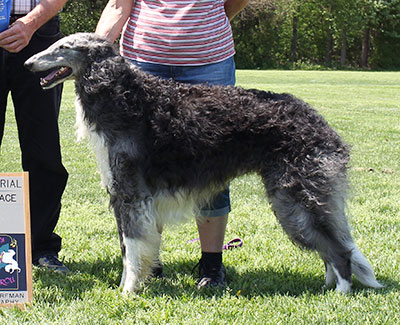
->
[350,243,383,288]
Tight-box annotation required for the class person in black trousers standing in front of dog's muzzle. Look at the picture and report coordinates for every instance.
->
[0,0,69,273]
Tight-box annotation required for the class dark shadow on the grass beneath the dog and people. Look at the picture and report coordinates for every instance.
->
[34,257,400,301]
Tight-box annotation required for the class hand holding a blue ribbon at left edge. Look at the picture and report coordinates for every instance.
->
[0,20,33,53]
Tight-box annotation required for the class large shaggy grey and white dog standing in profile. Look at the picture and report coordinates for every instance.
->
[26,33,381,292]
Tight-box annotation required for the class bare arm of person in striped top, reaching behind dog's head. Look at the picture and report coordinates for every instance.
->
[96,0,134,43]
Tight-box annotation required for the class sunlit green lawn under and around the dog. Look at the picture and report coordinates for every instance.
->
[0,71,400,324]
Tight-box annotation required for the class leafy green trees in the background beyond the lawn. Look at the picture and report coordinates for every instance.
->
[61,0,400,70]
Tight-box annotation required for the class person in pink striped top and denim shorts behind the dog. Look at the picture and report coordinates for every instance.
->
[96,0,248,289]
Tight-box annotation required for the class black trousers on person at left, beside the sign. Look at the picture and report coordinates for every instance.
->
[0,17,68,260]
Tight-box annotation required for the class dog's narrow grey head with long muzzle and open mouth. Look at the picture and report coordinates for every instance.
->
[25,33,117,89]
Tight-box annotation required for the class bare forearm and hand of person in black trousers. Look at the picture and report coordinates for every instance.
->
[0,0,67,53]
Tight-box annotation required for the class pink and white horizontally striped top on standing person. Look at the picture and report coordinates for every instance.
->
[121,0,235,65]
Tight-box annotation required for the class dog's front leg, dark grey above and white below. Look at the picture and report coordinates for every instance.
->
[108,151,161,292]
